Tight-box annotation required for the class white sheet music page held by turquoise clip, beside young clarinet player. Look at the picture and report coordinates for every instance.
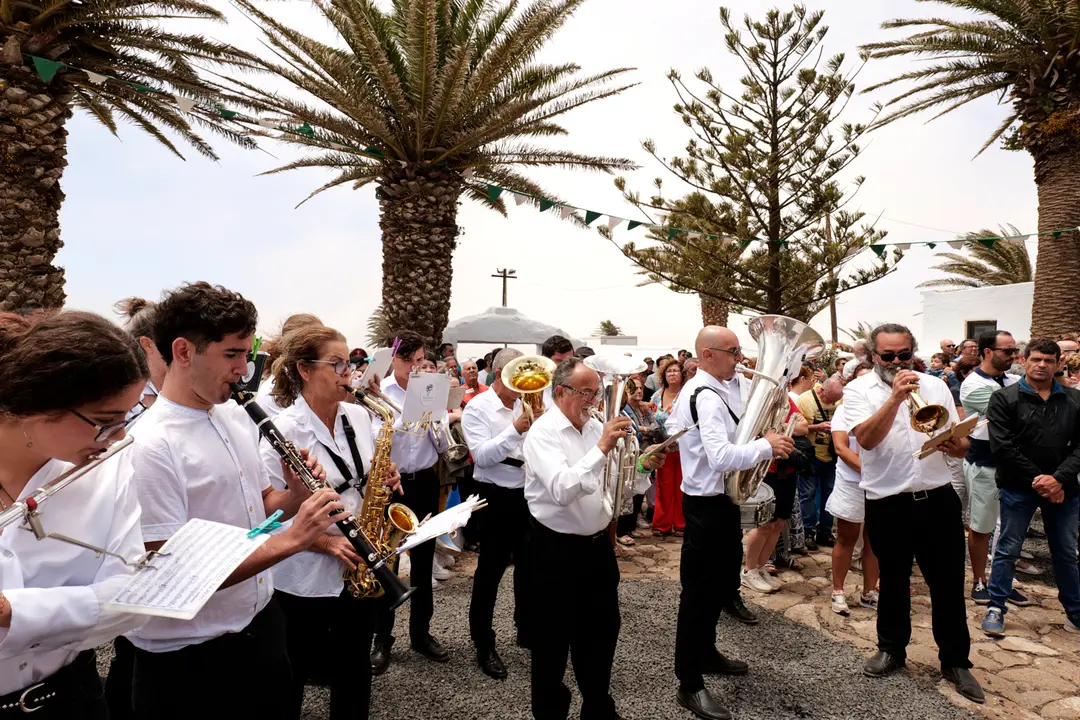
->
[105,518,270,620]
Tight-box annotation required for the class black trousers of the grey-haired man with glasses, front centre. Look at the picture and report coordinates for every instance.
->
[529,520,622,720]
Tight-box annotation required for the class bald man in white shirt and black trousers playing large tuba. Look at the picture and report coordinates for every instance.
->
[666,326,795,720]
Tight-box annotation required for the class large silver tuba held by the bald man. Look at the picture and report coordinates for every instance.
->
[724,315,825,511]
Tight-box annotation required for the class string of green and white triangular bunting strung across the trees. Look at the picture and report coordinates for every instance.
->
[27,55,1080,253]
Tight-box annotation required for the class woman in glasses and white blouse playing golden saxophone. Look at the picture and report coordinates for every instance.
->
[261,325,401,720]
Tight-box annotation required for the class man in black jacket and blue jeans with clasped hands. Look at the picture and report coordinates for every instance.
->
[983,340,1080,636]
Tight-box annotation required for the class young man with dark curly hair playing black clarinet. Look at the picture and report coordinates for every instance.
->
[129,283,345,720]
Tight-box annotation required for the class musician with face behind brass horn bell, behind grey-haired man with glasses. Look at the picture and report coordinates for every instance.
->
[461,349,534,680]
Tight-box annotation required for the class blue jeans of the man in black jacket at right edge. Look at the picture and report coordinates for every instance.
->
[989,488,1080,617]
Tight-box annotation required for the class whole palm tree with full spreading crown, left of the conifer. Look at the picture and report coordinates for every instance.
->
[227,0,634,343]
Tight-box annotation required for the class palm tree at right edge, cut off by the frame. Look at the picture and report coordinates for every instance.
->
[863,0,1080,337]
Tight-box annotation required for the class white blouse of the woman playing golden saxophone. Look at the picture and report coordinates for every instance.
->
[259,395,375,597]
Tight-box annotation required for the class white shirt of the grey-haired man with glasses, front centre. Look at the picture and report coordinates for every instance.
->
[524,403,611,535]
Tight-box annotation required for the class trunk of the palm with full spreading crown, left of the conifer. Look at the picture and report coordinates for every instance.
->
[378,165,461,348]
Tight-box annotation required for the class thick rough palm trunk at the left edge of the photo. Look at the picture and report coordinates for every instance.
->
[0,58,71,311]
